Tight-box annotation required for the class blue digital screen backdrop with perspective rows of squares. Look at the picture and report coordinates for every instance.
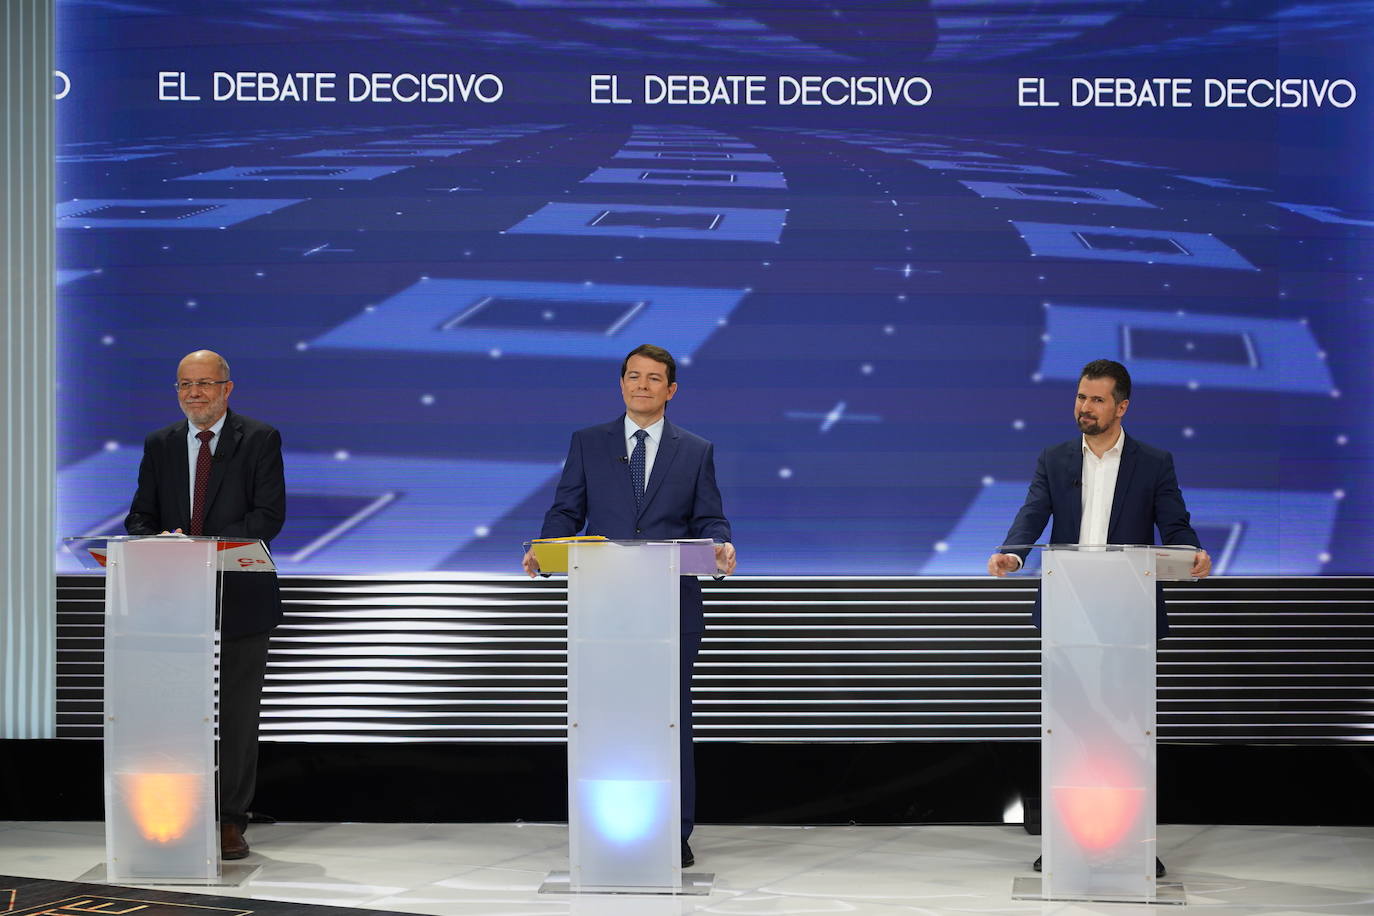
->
[56,0,1374,574]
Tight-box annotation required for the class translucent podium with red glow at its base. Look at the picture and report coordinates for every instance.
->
[1000,544,1195,904]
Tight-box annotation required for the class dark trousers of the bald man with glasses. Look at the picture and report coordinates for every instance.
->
[220,633,269,828]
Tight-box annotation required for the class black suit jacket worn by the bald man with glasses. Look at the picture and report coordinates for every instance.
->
[124,411,286,639]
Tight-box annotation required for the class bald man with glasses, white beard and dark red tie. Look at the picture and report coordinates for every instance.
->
[124,350,286,858]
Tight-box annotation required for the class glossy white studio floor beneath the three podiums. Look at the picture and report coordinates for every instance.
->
[0,821,1374,916]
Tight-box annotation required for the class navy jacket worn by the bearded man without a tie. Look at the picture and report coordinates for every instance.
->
[1003,435,1202,637]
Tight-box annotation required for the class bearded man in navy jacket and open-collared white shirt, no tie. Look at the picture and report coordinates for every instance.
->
[988,360,1212,878]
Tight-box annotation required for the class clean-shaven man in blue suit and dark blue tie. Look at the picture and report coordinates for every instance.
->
[523,343,735,868]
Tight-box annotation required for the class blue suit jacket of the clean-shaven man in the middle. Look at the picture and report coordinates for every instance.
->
[540,415,730,633]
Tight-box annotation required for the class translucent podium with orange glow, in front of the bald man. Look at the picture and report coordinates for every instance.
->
[66,536,273,884]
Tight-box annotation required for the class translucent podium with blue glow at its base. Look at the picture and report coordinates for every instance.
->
[533,538,716,894]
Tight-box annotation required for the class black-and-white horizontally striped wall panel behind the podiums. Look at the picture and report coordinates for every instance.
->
[58,577,1374,744]
